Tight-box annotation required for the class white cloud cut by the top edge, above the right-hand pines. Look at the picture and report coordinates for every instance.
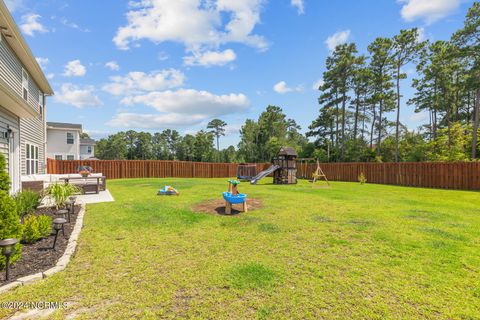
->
[398,0,461,24]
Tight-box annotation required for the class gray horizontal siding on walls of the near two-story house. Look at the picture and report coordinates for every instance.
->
[0,35,46,175]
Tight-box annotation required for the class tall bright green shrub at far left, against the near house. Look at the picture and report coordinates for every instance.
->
[0,190,22,269]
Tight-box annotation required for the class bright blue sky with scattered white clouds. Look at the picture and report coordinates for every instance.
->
[5,0,473,147]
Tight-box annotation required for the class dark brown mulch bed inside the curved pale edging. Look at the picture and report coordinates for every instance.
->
[0,205,81,286]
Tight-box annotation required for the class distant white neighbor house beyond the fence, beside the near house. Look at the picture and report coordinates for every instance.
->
[47,122,95,160]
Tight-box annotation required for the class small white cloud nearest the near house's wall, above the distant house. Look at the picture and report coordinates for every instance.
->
[54,83,102,108]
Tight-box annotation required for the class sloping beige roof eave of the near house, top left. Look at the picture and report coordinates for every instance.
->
[0,0,53,95]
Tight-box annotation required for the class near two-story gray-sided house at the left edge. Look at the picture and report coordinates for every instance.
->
[0,0,53,192]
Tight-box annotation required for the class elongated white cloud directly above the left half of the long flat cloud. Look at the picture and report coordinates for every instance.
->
[102,69,185,95]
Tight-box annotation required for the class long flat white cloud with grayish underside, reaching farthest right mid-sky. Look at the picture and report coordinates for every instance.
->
[121,89,250,118]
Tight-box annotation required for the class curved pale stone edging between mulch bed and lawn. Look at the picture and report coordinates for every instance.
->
[0,203,86,293]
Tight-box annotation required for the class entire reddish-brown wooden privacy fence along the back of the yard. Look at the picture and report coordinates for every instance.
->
[47,159,480,190]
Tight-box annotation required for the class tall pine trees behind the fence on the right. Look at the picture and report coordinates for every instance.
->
[307,2,480,161]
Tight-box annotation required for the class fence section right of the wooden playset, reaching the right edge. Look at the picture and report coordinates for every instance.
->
[298,162,480,190]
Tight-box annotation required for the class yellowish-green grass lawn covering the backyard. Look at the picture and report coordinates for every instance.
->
[0,178,480,319]
